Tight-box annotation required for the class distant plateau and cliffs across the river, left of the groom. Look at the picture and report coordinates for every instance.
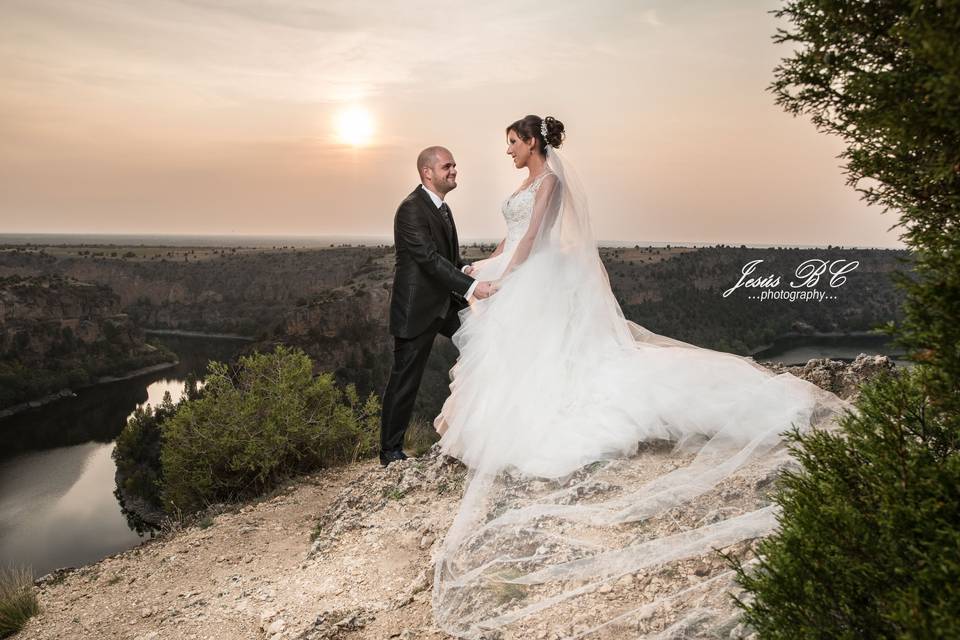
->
[0,247,392,336]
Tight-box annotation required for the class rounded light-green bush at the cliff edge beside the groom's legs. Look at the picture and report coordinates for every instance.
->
[160,345,380,513]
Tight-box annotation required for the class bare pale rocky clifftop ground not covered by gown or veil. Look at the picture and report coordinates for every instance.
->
[14,356,892,640]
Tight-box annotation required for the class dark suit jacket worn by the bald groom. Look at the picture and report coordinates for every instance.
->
[390,186,473,338]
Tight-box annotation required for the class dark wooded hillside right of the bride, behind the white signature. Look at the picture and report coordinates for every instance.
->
[616,247,909,355]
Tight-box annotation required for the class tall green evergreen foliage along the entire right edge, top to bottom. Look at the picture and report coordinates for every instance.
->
[734,0,960,638]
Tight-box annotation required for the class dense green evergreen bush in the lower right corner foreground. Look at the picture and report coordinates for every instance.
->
[734,367,960,639]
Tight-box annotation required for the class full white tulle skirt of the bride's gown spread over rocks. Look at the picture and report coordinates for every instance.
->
[434,247,840,478]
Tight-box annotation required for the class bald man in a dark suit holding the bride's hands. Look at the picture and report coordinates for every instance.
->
[380,147,491,466]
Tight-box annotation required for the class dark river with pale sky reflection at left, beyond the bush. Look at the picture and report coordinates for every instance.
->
[0,335,244,577]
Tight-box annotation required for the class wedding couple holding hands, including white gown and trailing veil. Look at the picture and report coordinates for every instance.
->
[380,115,851,639]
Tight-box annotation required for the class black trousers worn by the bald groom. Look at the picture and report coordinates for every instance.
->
[380,306,460,451]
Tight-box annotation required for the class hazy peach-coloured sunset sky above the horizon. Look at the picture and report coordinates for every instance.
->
[0,0,903,246]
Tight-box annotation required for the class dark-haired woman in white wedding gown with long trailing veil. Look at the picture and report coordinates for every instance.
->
[433,115,853,638]
